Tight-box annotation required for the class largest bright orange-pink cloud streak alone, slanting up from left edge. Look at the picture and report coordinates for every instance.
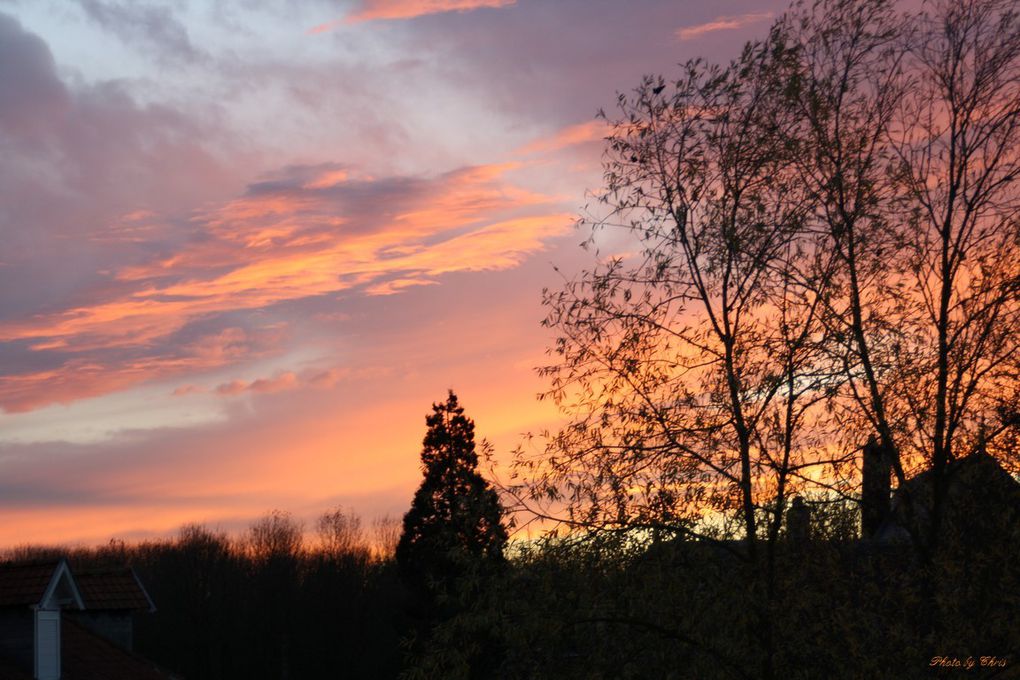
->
[0,164,570,373]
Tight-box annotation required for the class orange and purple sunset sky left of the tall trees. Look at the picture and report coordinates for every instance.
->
[0,0,786,546]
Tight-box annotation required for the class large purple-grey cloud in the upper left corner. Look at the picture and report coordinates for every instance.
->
[0,13,231,321]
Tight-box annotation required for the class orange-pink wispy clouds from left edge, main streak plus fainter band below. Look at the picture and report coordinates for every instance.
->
[0,163,571,411]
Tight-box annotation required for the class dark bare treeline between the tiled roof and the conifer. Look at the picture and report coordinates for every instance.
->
[4,508,407,680]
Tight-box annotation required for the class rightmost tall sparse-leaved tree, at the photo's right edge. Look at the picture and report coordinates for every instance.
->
[888,0,1020,544]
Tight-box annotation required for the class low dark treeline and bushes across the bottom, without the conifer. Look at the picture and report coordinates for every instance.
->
[4,491,1020,680]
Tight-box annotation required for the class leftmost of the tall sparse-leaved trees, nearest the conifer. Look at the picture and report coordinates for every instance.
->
[517,27,833,677]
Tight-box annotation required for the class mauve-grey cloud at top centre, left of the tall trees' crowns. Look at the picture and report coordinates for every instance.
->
[389,0,788,124]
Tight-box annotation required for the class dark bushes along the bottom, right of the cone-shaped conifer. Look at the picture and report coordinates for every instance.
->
[408,497,1020,680]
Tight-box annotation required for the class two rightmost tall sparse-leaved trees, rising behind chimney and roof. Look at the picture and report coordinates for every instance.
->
[781,0,1020,553]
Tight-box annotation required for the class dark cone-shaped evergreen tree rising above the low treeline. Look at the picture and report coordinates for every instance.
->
[397,390,507,589]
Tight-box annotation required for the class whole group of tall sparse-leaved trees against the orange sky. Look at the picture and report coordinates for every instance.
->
[511,0,1020,677]
